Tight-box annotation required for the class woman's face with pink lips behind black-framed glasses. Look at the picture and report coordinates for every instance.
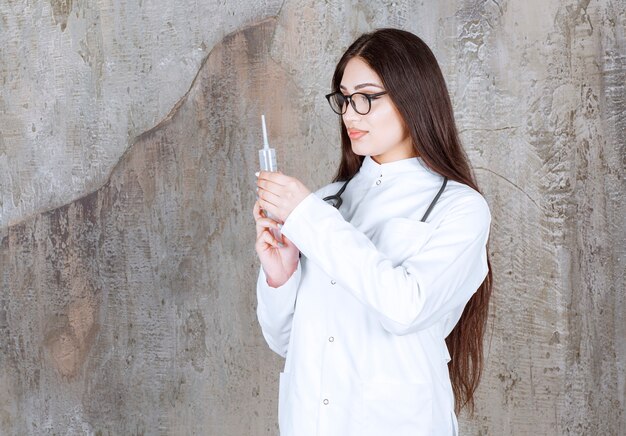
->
[340,57,416,164]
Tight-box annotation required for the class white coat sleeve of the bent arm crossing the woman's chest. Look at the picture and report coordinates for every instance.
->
[282,191,491,335]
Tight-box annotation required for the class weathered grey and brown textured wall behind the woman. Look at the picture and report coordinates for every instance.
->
[0,0,626,436]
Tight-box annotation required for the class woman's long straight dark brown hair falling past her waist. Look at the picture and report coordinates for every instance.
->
[332,29,492,413]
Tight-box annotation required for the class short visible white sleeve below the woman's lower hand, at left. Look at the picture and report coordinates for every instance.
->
[256,262,301,357]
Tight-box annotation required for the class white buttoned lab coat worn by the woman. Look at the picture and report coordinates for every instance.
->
[257,157,491,436]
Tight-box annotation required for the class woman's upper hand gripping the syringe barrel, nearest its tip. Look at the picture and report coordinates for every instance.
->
[256,171,311,223]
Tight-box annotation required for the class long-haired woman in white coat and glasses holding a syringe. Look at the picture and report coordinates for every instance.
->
[254,29,491,436]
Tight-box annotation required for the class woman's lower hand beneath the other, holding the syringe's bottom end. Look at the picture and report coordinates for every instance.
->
[253,200,300,288]
